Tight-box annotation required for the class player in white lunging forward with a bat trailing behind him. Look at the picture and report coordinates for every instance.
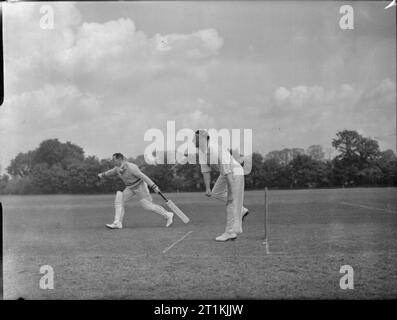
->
[98,153,174,229]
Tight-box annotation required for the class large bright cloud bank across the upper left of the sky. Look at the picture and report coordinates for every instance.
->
[4,3,223,94]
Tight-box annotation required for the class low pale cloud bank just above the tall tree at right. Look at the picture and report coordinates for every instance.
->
[267,78,396,153]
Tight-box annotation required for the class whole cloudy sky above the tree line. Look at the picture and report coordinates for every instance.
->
[0,1,396,171]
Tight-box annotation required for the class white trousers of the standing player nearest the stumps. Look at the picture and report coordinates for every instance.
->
[211,173,244,233]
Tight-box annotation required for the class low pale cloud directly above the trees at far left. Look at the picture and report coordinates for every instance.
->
[0,84,102,172]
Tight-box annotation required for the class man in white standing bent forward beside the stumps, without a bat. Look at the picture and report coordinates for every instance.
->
[195,130,248,241]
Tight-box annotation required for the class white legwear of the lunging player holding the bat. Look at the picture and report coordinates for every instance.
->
[114,181,168,223]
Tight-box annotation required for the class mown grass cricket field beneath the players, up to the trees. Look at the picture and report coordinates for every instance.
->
[0,188,397,299]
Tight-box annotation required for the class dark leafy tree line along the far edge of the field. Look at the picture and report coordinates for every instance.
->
[0,130,397,194]
